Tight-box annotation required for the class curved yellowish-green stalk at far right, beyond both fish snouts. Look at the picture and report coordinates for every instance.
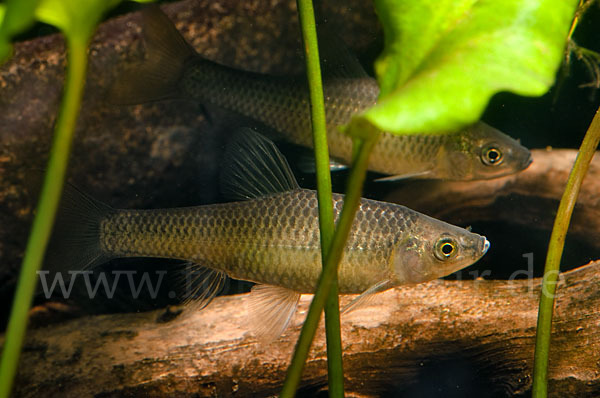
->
[532,108,600,398]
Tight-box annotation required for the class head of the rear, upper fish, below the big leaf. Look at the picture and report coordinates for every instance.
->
[442,122,532,181]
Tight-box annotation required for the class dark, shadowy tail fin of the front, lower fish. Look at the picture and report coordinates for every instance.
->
[42,184,115,284]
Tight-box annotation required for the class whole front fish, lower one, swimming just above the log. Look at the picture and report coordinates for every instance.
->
[48,128,490,340]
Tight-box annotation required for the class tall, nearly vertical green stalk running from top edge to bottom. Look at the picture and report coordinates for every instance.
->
[297,0,344,398]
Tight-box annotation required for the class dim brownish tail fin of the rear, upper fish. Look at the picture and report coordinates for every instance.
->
[109,5,197,105]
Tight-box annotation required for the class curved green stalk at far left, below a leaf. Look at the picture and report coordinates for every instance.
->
[0,38,87,398]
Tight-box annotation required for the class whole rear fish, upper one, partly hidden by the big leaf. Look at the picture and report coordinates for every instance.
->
[109,6,532,181]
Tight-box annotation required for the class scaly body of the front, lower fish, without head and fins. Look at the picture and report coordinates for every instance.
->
[100,189,417,293]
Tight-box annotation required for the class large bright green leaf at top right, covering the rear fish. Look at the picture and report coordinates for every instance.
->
[346,0,578,134]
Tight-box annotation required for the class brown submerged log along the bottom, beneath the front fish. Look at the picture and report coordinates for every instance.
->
[7,263,600,397]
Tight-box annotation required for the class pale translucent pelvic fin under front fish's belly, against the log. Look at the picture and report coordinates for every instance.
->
[248,285,300,343]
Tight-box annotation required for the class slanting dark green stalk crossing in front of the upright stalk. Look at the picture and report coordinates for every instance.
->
[280,133,379,398]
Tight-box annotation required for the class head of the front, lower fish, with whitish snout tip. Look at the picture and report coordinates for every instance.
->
[392,215,490,284]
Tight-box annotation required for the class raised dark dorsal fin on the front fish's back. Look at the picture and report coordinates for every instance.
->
[221,128,300,200]
